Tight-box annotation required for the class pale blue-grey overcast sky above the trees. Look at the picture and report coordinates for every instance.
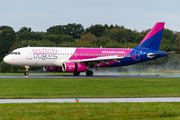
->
[0,0,180,32]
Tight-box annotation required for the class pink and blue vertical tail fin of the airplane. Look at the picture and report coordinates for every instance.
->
[136,22,165,50]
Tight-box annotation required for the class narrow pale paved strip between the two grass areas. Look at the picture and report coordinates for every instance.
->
[0,97,180,104]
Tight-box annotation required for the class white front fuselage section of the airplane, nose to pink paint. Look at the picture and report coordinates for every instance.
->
[4,47,75,67]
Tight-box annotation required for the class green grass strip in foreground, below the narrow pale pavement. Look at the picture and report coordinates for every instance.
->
[0,102,180,120]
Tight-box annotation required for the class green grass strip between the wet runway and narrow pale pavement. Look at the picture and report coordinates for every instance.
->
[0,78,180,98]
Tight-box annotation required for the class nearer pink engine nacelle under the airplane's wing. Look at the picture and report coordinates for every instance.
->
[62,62,87,72]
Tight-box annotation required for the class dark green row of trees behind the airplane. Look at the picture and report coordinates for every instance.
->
[0,23,180,72]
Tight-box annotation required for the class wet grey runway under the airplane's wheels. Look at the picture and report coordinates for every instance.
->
[0,75,180,78]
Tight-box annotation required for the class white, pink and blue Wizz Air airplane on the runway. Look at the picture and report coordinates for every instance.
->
[3,22,173,76]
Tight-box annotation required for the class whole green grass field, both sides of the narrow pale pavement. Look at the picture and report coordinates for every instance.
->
[0,78,180,120]
